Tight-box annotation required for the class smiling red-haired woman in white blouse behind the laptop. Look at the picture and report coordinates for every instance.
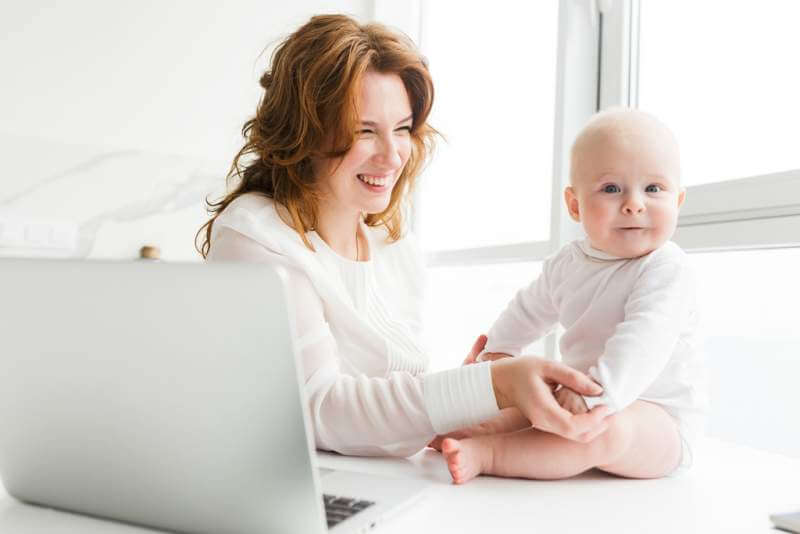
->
[198,15,605,456]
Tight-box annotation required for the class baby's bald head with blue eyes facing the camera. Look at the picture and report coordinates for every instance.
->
[564,109,685,258]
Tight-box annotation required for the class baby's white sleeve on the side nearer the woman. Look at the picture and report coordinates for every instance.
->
[486,260,558,356]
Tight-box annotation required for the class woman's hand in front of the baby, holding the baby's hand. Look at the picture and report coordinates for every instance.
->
[488,356,609,442]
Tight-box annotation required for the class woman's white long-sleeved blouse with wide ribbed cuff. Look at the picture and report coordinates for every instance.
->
[208,193,499,456]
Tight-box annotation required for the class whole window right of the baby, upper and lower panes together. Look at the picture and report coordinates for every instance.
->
[632,0,800,456]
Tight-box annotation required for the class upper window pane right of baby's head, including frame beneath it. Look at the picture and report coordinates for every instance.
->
[632,0,800,250]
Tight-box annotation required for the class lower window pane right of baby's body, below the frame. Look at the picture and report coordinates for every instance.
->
[692,248,800,455]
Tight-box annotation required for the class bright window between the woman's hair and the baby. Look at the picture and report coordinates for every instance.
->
[415,0,560,369]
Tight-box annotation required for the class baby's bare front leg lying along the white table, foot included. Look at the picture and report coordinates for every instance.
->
[442,401,681,484]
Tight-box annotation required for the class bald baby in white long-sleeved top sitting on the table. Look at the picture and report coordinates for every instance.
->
[439,110,704,484]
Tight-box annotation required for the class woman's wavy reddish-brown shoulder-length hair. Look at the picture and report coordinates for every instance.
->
[195,15,436,258]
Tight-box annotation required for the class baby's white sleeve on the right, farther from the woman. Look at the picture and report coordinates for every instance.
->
[584,253,694,412]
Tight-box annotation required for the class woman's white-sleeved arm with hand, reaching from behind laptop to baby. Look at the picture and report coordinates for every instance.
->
[209,227,602,456]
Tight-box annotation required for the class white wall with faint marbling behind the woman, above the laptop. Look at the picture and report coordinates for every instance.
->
[0,0,373,260]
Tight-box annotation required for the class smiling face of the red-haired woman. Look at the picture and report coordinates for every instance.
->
[316,71,413,215]
